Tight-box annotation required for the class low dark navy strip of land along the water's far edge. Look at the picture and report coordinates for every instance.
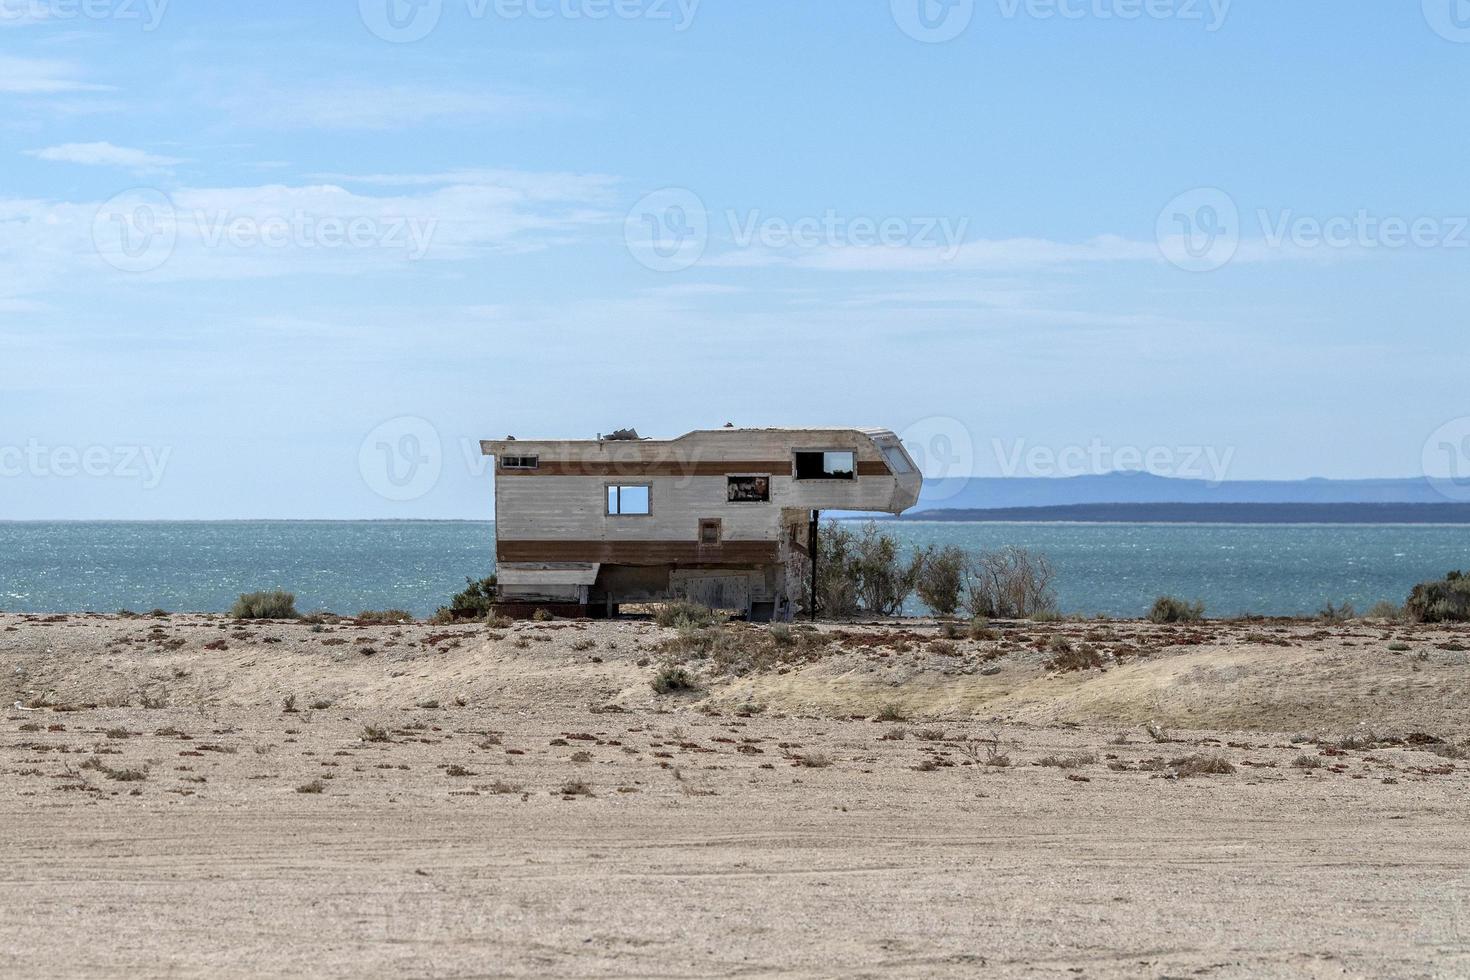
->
[898,502,1470,525]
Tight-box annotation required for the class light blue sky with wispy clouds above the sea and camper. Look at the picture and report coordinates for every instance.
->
[0,0,1470,520]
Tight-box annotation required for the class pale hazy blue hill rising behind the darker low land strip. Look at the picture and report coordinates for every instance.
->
[911,473,1448,513]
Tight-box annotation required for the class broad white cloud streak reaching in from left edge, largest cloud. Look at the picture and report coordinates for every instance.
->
[0,173,612,301]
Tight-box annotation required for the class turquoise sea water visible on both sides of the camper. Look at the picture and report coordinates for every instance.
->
[0,522,1470,616]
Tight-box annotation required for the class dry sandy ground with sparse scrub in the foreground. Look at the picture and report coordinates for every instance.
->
[0,614,1470,977]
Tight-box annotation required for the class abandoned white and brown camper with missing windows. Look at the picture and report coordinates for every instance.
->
[481,426,922,620]
